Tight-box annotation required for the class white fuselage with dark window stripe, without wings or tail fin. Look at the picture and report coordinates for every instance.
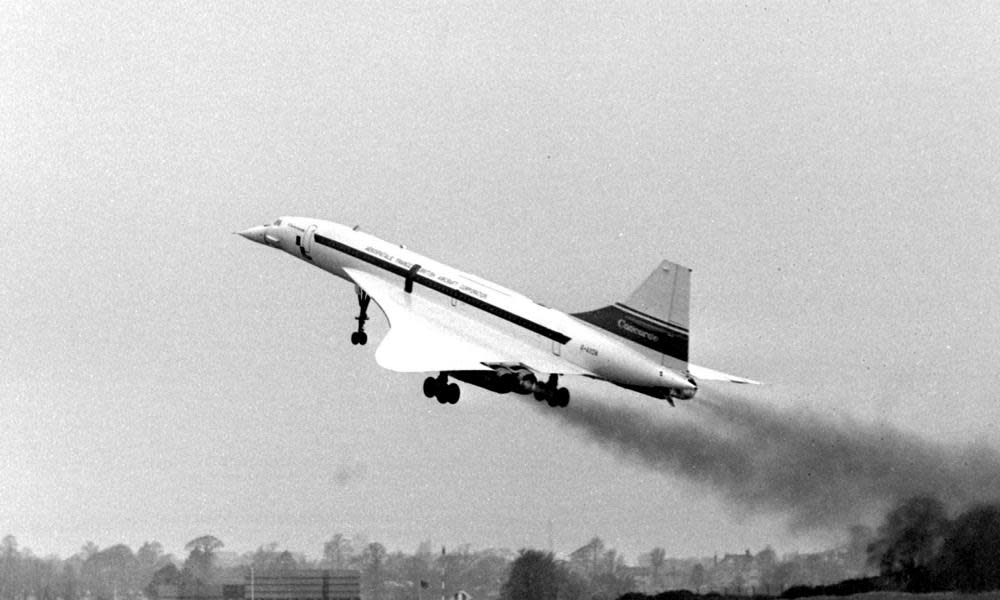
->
[244,217,694,398]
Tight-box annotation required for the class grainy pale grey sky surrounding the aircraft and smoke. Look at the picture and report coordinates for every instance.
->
[0,2,1000,556]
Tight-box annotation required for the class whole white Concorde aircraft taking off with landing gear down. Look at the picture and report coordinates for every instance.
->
[239,217,758,407]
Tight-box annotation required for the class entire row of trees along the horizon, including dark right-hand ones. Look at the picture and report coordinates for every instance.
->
[0,497,1000,600]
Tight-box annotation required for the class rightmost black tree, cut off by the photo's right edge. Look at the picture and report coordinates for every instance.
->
[934,504,1000,592]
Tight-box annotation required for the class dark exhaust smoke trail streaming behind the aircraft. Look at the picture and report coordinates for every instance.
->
[543,389,1000,530]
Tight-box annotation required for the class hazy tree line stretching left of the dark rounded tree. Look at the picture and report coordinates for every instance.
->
[0,534,513,600]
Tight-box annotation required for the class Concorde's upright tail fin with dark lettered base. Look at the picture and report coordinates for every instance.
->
[573,260,691,372]
